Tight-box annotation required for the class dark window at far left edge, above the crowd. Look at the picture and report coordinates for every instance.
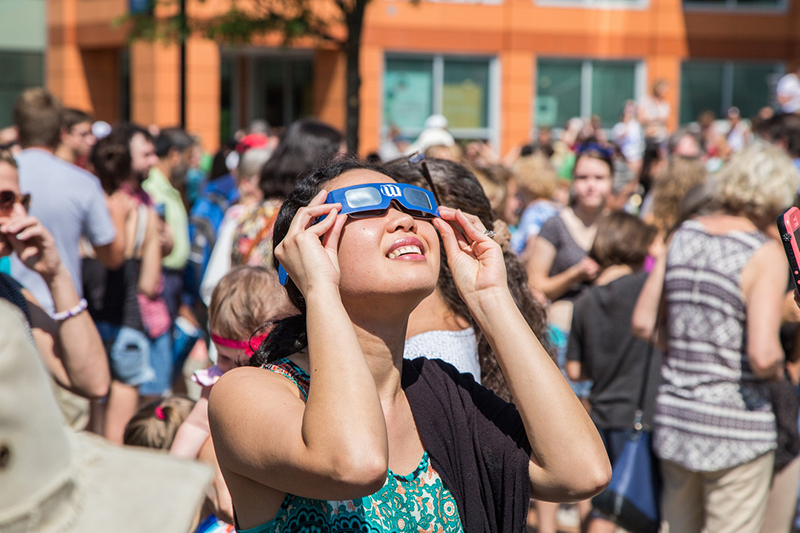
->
[0,50,44,128]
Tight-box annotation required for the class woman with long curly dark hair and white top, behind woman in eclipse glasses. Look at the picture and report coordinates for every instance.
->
[386,155,549,394]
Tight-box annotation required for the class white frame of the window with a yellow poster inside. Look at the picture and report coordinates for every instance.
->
[378,50,501,146]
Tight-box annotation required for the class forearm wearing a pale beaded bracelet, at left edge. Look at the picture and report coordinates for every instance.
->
[45,265,111,398]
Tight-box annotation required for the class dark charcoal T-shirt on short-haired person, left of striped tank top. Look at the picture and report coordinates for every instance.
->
[567,272,661,429]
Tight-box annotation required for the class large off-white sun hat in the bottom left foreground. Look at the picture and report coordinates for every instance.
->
[0,299,211,533]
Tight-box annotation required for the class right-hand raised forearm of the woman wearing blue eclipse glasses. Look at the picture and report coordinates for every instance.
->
[470,291,611,501]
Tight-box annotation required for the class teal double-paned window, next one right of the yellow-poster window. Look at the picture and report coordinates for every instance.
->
[536,59,644,128]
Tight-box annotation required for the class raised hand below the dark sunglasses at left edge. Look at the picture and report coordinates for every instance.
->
[0,215,62,280]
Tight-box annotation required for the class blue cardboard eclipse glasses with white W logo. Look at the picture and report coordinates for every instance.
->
[278,183,439,285]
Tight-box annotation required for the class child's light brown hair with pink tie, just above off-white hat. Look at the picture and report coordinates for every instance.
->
[122,395,194,451]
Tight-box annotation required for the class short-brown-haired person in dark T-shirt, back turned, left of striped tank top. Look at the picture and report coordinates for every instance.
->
[567,211,661,533]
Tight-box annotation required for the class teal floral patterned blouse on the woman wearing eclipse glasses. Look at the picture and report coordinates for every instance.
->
[239,359,463,533]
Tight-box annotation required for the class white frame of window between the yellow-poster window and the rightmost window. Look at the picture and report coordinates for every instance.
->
[531,55,647,135]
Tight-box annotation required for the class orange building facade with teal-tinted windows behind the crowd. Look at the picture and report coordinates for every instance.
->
[39,0,800,153]
